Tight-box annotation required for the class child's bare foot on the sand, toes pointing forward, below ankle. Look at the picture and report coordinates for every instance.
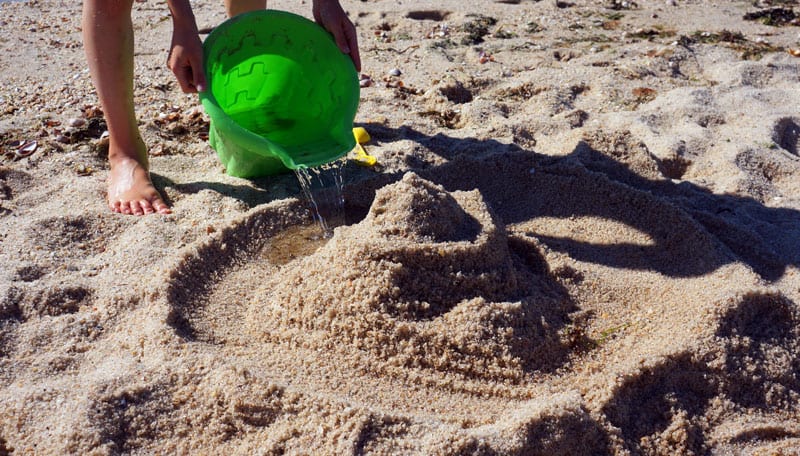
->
[108,157,172,215]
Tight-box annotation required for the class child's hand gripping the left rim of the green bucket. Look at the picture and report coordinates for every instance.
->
[167,26,206,93]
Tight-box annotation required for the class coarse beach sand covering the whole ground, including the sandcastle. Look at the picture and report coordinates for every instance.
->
[0,0,800,455]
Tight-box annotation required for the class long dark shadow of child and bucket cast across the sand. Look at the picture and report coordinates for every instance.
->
[166,124,800,281]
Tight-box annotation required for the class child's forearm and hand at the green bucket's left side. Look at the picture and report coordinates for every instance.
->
[167,0,206,93]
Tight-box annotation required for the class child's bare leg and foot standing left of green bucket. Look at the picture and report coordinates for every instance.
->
[83,0,171,215]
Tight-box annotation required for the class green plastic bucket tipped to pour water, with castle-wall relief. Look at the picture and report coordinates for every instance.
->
[200,10,360,177]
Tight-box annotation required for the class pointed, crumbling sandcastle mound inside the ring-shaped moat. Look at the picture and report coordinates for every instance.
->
[248,173,566,380]
